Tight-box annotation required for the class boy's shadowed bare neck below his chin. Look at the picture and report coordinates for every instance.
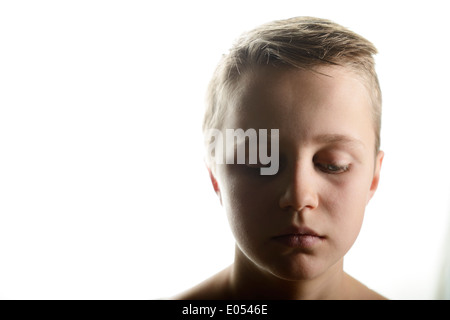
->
[228,247,346,300]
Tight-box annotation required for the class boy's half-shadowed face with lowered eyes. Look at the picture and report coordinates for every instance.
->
[212,66,383,280]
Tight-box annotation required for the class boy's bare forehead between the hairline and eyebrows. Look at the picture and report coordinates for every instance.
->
[224,66,375,152]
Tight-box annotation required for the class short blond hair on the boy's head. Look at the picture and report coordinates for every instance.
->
[203,17,381,154]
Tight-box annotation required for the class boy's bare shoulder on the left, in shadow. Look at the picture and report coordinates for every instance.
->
[171,268,229,300]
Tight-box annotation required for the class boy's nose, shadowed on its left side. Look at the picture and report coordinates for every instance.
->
[279,163,319,212]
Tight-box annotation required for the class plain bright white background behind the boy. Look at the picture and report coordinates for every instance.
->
[0,0,450,299]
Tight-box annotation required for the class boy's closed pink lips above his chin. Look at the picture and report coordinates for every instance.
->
[272,227,325,249]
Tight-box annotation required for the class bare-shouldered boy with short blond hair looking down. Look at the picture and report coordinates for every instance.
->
[176,17,384,299]
